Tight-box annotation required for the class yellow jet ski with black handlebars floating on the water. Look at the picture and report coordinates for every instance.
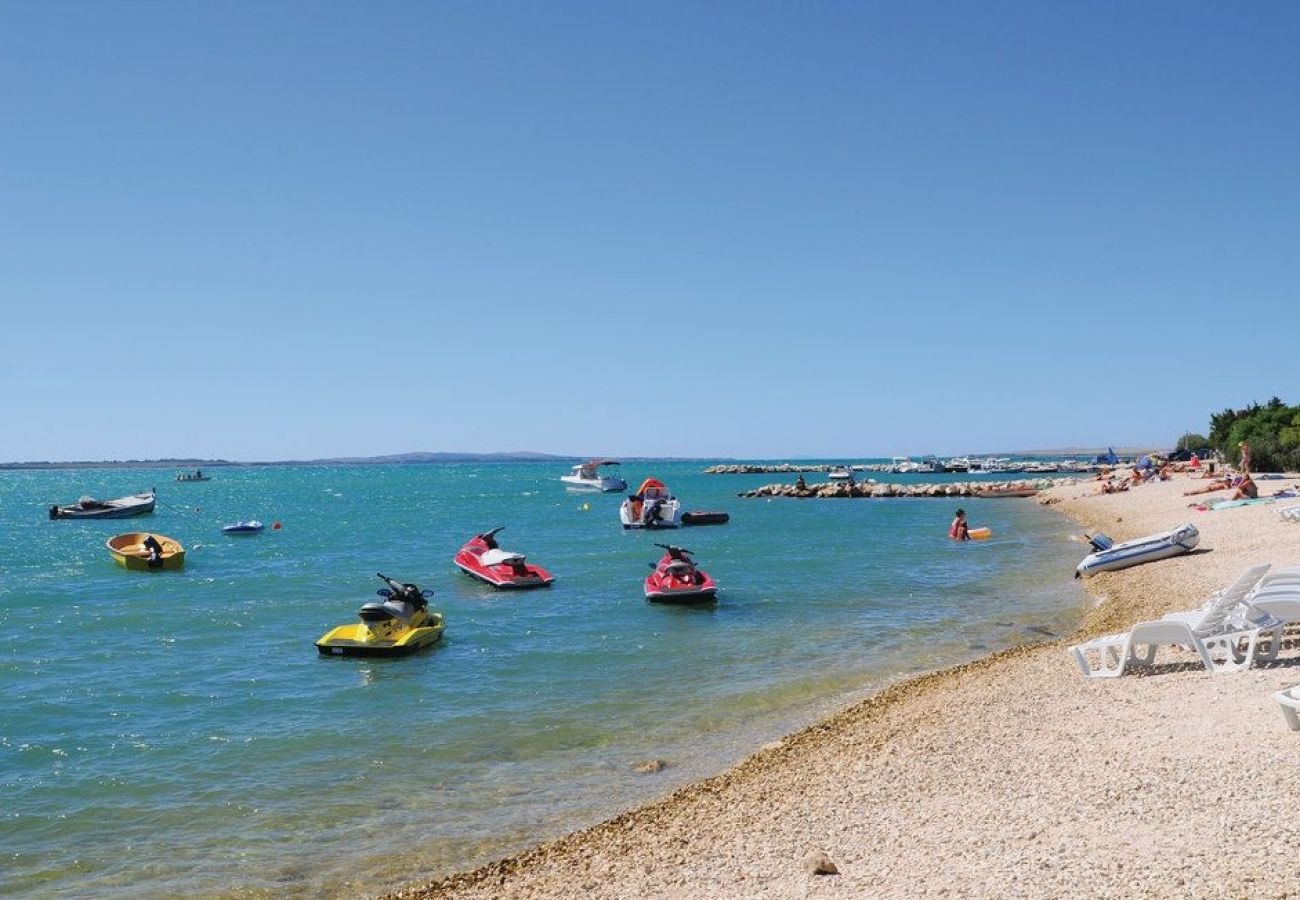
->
[316,572,445,657]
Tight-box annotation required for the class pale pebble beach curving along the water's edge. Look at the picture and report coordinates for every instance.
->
[391,477,1300,897]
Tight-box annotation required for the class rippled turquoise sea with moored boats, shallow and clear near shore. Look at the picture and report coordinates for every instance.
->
[0,462,1086,896]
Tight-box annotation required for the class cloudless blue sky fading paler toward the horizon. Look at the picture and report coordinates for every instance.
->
[0,0,1300,460]
